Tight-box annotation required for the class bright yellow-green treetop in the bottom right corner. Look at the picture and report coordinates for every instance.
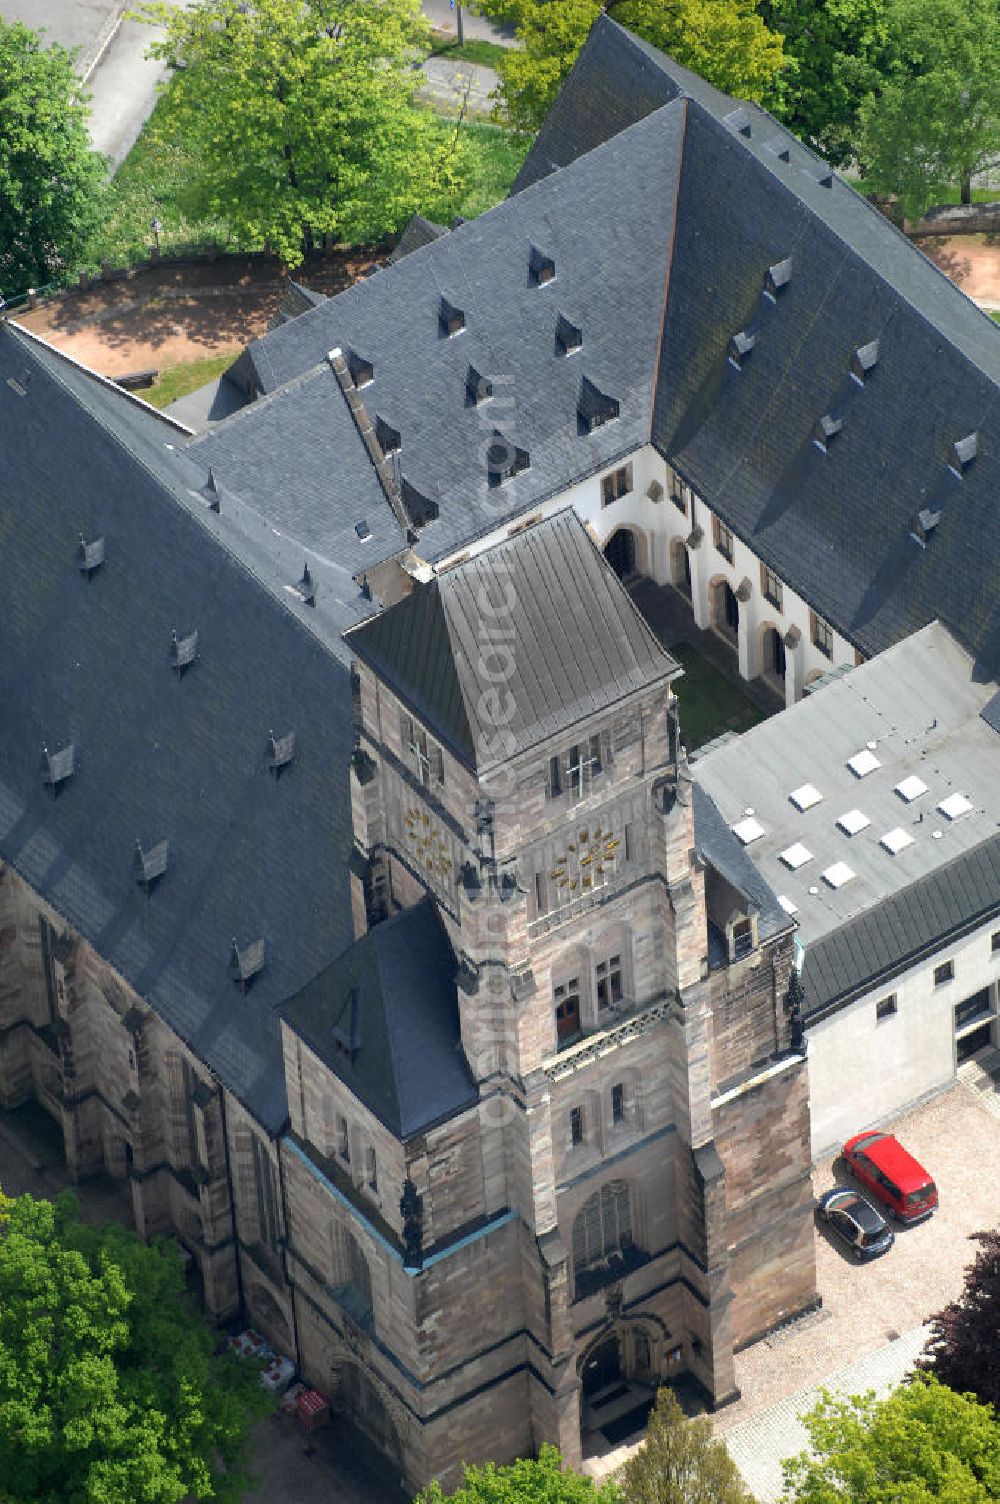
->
[782,1375,1000,1504]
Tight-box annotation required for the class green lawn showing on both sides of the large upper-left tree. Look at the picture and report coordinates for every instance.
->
[92,76,531,269]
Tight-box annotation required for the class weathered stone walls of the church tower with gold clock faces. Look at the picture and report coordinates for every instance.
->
[275,522,815,1483]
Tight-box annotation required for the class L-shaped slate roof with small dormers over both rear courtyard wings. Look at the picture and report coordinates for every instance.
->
[192,15,1000,671]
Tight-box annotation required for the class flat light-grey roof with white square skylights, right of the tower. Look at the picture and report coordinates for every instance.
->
[693,623,1000,1009]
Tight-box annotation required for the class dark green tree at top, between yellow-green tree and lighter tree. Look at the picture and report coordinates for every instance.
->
[761,0,893,167]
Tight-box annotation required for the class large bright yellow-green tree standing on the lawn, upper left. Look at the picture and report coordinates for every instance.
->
[141,0,460,266]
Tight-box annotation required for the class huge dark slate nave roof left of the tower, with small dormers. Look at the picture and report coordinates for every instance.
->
[0,323,353,1131]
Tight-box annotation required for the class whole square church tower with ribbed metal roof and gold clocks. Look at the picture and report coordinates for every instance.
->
[276,511,814,1481]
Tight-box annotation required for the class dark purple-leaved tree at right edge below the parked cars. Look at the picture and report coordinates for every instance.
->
[917,1232,1000,1415]
